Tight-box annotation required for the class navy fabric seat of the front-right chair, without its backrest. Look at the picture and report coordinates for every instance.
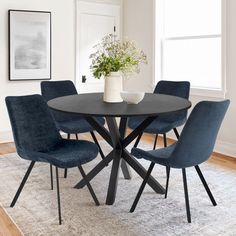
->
[131,143,176,167]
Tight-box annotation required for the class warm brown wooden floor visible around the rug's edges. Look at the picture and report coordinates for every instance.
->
[0,134,236,236]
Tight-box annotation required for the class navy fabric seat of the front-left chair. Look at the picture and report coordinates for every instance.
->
[19,139,98,168]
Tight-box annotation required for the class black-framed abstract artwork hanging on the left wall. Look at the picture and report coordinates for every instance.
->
[8,10,51,81]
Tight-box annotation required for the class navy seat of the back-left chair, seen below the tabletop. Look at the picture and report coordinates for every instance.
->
[57,117,105,134]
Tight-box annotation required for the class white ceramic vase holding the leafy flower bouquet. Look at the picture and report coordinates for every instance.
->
[103,71,123,103]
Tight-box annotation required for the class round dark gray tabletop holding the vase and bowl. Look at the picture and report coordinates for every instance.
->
[48,93,191,117]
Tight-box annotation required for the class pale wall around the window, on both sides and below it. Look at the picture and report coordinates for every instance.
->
[124,0,236,157]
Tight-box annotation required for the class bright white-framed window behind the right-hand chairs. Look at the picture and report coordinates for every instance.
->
[156,0,224,97]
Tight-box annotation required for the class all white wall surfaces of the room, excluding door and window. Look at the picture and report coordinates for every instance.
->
[0,0,236,159]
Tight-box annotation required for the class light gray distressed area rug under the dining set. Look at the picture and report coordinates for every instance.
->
[0,143,236,236]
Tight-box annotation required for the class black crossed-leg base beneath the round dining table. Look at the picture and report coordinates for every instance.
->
[75,117,165,205]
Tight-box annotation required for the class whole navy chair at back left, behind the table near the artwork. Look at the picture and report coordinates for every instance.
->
[41,80,105,180]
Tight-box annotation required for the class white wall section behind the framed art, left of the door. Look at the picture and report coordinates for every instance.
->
[0,0,75,142]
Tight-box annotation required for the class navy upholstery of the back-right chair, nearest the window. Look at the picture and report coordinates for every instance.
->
[128,80,190,134]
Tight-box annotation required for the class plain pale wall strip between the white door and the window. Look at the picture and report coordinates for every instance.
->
[123,0,154,92]
